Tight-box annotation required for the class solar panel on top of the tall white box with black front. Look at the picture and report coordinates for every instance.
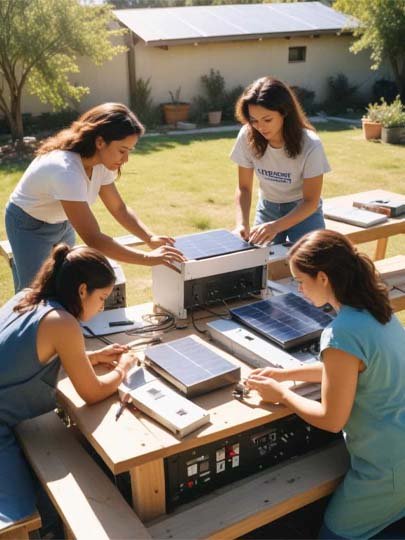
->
[174,229,255,260]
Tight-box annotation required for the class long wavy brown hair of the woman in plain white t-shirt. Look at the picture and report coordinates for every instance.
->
[37,103,145,158]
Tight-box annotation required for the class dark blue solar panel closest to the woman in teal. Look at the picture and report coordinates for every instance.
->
[230,293,332,349]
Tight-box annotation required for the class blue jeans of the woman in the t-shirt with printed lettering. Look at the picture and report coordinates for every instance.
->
[255,198,325,244]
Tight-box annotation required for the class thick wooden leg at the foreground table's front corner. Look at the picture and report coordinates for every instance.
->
[130,459,166,521]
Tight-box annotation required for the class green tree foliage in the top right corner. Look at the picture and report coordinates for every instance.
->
[333,0,405,99]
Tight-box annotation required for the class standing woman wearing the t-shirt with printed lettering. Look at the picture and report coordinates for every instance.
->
[231,77,330,244]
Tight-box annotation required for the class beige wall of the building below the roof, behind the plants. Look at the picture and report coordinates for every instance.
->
[2,36,391,119]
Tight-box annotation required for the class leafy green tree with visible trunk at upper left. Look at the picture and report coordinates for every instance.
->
[0,0,126,140]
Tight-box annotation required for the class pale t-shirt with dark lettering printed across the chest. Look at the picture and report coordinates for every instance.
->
[230,126,330,203]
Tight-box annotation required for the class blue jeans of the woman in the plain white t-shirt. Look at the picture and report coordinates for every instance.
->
[6,202,76,293]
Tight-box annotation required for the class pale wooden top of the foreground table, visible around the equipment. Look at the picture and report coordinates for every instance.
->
[58,303,316,474]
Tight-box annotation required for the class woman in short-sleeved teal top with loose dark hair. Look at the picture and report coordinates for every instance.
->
[247,230,405,540]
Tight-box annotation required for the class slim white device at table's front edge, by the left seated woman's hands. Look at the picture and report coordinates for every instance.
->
[118,367,210,437]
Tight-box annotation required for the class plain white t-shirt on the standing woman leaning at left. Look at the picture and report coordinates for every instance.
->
[10,150,116,223]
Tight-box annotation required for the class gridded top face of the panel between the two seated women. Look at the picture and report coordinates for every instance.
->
[145,337,237,386]
